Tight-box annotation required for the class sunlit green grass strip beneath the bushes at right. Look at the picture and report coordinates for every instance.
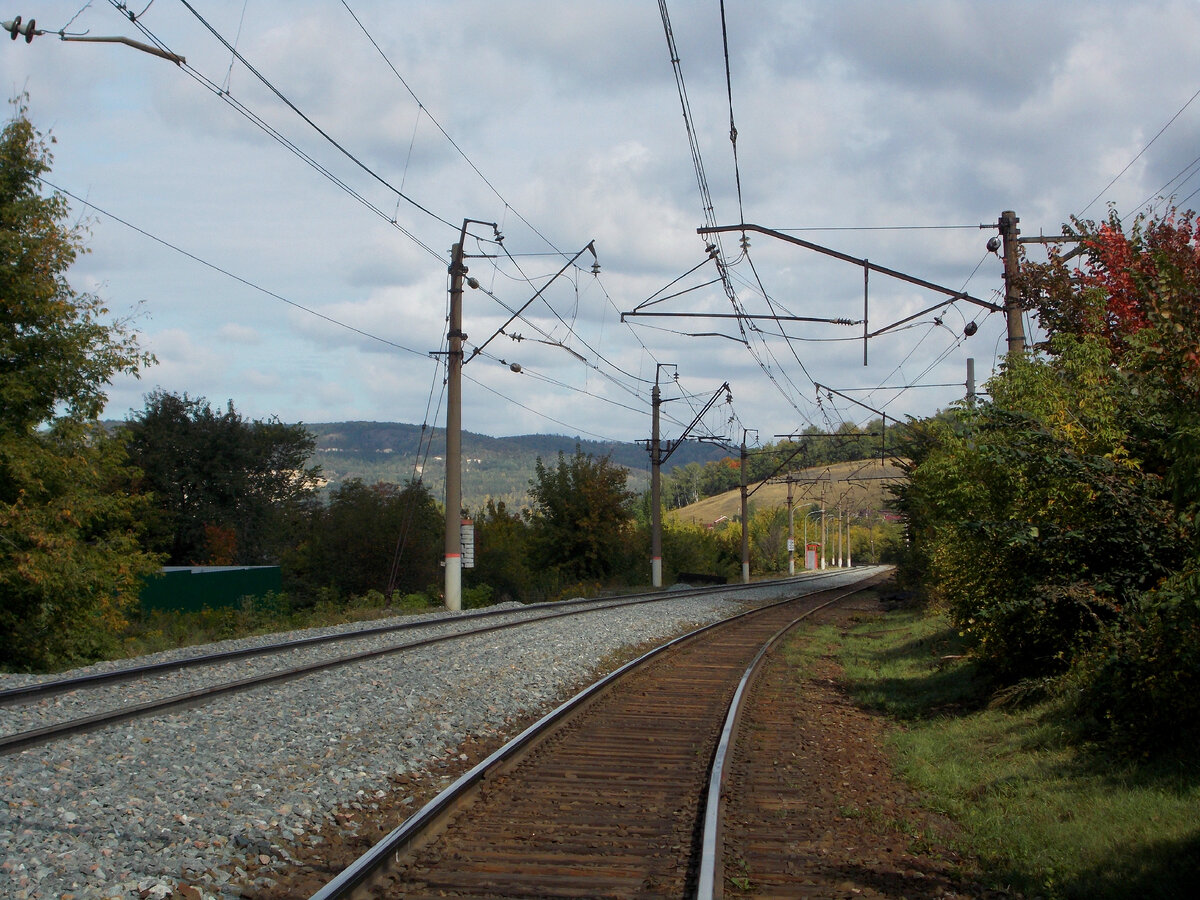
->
[827,612,1200,900]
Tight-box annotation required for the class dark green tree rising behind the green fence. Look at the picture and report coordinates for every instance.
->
[122,390,319,565]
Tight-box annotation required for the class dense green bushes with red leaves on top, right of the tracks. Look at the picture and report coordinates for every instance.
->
[899,207,1200,746]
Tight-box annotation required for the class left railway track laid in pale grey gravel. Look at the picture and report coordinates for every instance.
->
[0,572,854,756]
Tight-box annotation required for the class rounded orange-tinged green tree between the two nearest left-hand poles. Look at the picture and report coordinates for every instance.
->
[529,448,634,581]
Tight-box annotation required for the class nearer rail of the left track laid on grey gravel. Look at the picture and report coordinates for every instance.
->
[0,576,854,756]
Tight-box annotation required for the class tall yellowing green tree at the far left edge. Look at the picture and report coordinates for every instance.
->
[0,104,157,670]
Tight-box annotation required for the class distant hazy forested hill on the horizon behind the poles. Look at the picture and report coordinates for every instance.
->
[305,422,725,510]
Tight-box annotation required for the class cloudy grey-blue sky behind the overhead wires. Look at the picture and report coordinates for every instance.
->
[0,0,1200,451]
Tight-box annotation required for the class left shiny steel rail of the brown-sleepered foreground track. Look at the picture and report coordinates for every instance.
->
[310,570,878,900]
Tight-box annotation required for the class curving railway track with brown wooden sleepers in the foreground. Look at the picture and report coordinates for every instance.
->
[312,570,883,900]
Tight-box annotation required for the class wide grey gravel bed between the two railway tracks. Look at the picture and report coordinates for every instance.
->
[0,578,878,900]
